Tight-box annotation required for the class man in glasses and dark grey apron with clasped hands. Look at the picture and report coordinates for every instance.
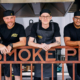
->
[28,9,61,80]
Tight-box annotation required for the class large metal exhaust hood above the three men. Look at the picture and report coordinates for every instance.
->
[0,0,76,17]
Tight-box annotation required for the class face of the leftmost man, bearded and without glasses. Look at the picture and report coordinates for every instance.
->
[3,16,15,27]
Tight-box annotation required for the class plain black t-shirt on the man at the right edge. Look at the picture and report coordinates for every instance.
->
[64,23,80,41]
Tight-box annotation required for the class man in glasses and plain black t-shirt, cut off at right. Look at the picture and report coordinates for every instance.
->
[64,11,80,80]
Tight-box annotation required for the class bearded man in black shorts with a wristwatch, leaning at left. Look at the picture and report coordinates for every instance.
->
[0,10,26,80]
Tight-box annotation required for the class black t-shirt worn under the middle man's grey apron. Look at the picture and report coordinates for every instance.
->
[30,22,60,38]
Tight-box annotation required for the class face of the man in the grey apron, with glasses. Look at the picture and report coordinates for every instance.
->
[39,13,52,25]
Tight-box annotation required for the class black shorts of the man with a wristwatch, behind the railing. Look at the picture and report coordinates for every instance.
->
[2,54,20,77]
